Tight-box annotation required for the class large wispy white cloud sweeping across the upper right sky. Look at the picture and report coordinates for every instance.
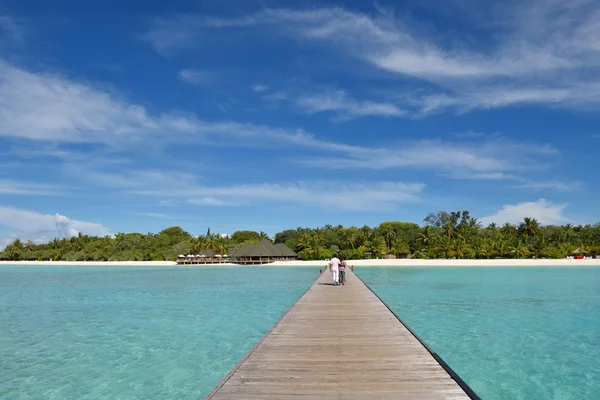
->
[146,0,600,115]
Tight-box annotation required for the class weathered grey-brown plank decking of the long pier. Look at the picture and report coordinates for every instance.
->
[207,271,477,400]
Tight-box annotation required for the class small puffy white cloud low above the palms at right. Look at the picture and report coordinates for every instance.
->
[479,199,571,225]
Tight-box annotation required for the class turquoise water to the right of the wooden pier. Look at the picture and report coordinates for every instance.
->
[356,267,600,400]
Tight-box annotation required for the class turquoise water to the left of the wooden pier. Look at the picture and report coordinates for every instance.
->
[0,266,318,400]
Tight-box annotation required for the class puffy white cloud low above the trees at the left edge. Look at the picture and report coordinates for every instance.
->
[0,206,110,247]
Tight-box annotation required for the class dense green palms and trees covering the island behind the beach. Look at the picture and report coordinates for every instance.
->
[0,211,600,261]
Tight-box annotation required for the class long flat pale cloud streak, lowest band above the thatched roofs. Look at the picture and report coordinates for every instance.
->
[72,171,425,210]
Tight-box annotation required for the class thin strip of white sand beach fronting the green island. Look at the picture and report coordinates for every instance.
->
[0,259,600,269]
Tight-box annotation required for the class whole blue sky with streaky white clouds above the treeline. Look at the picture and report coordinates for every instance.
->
[0,0,600,245]
